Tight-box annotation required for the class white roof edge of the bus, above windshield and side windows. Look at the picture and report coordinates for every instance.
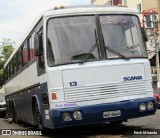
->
[4,5,138,67]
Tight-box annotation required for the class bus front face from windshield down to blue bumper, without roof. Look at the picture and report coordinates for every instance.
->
[46,14,155,127]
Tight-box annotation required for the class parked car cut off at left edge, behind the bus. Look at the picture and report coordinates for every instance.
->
[0,93,6,117]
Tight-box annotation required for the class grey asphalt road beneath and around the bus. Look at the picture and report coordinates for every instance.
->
[0,110,160,138]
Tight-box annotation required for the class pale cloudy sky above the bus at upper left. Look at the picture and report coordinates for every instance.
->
[0,0,91,44]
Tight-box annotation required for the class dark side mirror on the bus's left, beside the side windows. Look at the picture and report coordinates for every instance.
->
[34,34,43,56]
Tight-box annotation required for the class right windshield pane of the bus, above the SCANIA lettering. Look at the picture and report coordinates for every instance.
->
[100,15,146,58]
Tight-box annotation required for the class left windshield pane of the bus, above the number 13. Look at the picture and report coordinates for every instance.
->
[47,16,99,66]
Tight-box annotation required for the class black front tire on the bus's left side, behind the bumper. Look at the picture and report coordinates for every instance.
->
[34,102,43,130]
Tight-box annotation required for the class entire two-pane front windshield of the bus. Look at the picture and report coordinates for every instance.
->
[47,15,146,66]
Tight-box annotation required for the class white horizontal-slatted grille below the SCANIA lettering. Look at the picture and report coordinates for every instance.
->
[64,81,147,102]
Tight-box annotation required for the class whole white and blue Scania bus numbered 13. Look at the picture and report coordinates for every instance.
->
[1,6,156,129]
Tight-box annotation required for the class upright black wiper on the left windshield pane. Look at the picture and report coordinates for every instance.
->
[79,30,98,64]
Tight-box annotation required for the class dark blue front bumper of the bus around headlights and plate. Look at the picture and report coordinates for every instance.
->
[50,98,156,128]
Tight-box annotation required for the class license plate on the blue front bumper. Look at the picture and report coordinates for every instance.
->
[103,110,121,118]
